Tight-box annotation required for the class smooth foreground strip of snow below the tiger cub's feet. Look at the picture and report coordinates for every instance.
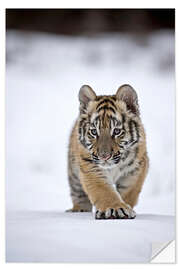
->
[6,211,174,263]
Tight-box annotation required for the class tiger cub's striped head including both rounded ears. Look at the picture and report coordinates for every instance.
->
[78,85,142,169]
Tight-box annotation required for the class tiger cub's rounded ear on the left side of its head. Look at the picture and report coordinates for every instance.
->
[79,85,96,107]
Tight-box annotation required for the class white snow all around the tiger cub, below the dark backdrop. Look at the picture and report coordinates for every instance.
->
[6,31,175,262]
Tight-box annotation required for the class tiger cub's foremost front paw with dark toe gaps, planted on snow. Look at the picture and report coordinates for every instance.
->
[95,207,136,219]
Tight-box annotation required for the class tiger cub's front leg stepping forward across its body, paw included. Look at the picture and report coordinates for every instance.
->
[80,171,135,219]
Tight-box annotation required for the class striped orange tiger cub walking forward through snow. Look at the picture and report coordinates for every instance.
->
[67,84,148,219]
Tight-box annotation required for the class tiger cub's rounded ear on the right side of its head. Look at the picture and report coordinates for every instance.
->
[116,84,140,115]
